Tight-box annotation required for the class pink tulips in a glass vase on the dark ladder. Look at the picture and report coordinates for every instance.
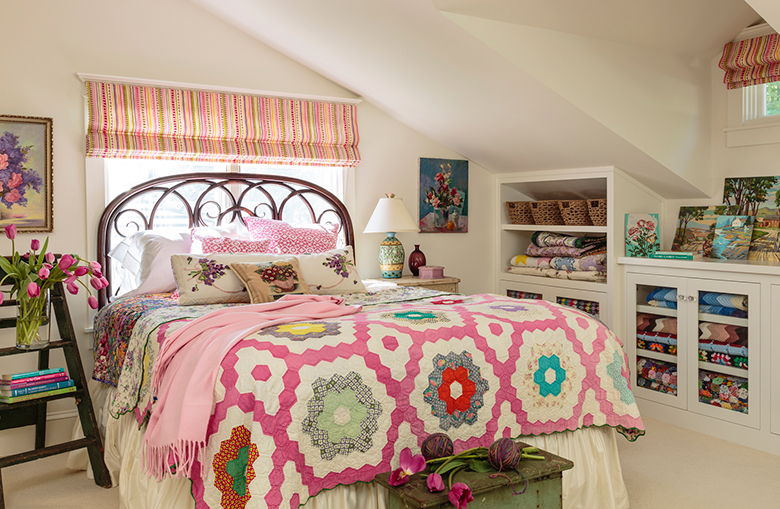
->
[0,224,108,349]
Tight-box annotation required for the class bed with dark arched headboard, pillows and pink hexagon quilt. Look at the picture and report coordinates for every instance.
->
[69,173,644,509]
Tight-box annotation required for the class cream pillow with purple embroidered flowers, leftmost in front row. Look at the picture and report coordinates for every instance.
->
[170,253,278,306]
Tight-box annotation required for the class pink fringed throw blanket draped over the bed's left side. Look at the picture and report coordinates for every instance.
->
[144,295,361,481]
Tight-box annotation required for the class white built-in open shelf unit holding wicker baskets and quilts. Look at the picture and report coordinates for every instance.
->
[496,166,663,329]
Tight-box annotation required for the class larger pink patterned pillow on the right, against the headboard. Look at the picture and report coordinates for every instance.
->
[245,217,338,254]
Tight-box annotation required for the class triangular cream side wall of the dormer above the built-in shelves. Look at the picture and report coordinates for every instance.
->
[444,13,711,196]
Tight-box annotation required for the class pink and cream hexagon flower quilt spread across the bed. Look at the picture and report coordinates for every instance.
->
[100,295,644,508]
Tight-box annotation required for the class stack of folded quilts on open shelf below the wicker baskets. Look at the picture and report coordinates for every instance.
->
[509,232,607,282]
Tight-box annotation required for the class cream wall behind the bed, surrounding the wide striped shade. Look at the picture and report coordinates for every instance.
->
[0,0,494,454]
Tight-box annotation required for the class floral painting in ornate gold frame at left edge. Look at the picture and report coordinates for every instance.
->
[0,115,53,232]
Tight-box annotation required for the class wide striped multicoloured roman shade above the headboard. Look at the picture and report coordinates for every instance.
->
[86,81,360,167]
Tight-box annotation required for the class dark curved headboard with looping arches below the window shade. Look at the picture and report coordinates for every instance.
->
[97,173,355,307]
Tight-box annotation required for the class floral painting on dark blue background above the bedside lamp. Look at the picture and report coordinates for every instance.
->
[419,157,469,233]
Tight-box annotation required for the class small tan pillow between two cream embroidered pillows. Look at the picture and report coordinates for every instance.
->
[230,256,311,304]
